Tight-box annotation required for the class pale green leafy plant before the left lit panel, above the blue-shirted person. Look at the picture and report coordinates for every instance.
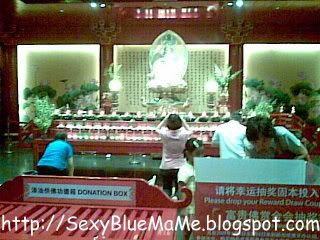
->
[33,97,55,133]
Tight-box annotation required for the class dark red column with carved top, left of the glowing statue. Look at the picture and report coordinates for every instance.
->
[93,16,120,103]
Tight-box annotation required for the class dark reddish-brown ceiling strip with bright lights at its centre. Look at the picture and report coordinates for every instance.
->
[0,0,320,25]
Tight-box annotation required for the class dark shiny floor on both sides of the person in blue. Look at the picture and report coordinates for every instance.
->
[0,149,160,184]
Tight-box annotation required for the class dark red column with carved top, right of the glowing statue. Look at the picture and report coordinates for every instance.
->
[222,18,253,111]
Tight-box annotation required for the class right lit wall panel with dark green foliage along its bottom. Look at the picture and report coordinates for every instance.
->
[243,44,320,124]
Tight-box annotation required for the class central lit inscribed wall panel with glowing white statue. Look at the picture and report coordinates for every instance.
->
[114,31,229,113]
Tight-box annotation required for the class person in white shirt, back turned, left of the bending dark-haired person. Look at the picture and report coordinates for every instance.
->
[212,111,246,159]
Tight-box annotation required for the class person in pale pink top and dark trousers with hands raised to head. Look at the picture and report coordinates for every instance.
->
[157,114,191,197]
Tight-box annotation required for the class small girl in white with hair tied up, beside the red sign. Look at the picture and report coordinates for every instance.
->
[178,138,203,240]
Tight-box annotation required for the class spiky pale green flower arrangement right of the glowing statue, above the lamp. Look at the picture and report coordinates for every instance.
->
[212,64,242,89]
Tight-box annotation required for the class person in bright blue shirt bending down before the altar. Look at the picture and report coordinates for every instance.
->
[37,133,74,176]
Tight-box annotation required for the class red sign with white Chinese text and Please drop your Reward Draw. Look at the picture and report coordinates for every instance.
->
[195,183,320,240]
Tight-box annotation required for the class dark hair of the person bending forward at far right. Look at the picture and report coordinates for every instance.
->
[246,116,276,141]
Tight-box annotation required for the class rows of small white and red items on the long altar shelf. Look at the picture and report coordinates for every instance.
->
[51,117,220,143]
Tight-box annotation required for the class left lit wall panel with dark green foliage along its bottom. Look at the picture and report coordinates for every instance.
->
[17,44,100,121]
